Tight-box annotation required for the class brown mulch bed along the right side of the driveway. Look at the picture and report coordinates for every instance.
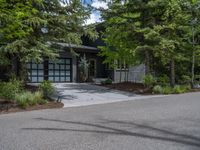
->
[101,82,152,95]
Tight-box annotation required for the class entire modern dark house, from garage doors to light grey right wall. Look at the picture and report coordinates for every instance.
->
[0,26,145,83]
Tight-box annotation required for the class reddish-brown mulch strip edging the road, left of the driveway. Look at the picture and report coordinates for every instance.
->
[0,99,64,114]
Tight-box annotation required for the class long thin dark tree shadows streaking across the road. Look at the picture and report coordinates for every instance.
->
[22,118,200,147]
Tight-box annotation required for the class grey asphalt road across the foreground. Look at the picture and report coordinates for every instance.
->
[0,93,200,150]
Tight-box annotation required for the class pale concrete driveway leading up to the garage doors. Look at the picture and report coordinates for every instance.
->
[54,83,159,107]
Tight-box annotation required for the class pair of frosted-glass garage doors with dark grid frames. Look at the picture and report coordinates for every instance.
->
[27,58,72,82]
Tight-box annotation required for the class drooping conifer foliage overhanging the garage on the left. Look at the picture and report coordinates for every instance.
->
[0,0,96,80]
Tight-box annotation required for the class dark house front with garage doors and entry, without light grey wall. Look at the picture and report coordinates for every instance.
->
[26,43,107,83]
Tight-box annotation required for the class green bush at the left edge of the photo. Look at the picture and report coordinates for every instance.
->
[0,79,22,100]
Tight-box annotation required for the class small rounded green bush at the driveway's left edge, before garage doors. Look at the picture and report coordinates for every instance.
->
[39,80,54,98]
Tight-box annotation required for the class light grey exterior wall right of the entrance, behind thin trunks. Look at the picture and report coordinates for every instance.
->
[113,64,145,83]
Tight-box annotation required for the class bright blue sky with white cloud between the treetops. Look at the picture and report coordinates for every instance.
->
[86,0,108,24]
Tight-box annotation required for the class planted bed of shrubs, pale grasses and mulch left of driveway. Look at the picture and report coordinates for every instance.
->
[0,79,63,114]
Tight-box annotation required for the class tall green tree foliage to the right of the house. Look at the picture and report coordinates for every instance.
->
[101,0,200,88]
